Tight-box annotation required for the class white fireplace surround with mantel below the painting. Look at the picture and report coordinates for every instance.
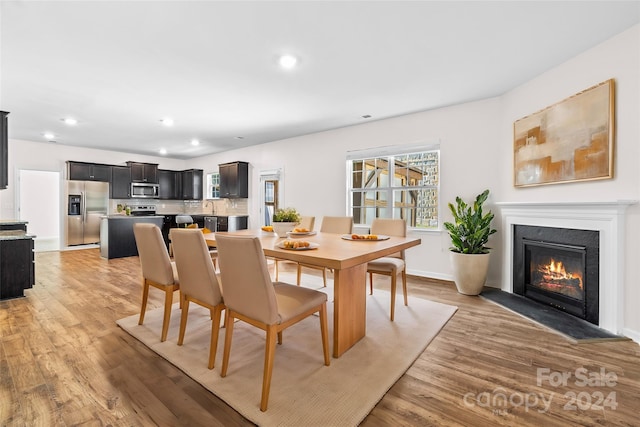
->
[496,200,637,334]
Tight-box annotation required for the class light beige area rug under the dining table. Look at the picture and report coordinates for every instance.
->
[117,282,457,427]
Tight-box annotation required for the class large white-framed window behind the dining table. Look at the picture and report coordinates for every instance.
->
[347,146,440,230]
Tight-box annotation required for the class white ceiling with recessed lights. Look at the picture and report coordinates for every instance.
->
[0,0,640,159]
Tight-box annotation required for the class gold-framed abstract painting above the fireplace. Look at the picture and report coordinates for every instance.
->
[513,79,615,187]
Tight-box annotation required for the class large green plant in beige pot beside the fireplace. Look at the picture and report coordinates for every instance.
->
[444,190,496,295]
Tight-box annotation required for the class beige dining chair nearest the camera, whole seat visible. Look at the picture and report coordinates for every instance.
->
[216,235,330,412]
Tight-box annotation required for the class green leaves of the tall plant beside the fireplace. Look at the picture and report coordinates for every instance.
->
[444,190,497,254]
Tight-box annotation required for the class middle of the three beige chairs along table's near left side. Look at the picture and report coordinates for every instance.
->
[173,228,225,369]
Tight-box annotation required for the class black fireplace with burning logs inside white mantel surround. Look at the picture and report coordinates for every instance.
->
[512,225,600,325]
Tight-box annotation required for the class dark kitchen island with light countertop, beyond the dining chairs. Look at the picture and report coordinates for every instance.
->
[100,215,164,259]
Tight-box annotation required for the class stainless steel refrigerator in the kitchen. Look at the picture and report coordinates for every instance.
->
[66,181,109,246]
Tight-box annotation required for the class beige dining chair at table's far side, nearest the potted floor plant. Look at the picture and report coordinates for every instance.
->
[367,218,409,321]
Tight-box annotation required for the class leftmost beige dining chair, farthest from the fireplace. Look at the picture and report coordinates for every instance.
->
[133,223,180,341]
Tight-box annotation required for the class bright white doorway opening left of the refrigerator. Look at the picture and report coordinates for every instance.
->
[17,169,60,252]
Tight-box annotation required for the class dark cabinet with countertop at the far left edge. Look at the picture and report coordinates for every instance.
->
[0,220,36,299]
